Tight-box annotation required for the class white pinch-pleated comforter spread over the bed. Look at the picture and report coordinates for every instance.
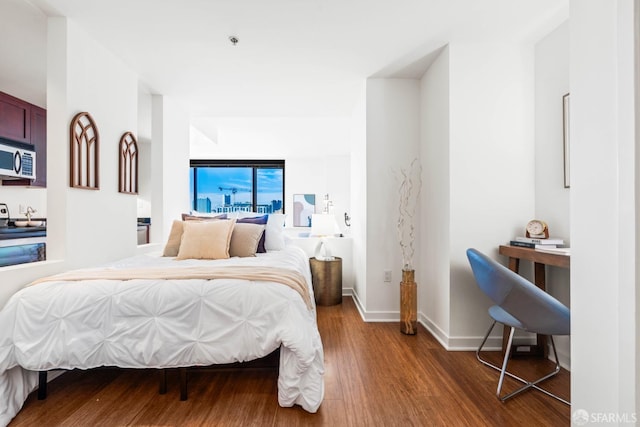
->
[0,247,324,425]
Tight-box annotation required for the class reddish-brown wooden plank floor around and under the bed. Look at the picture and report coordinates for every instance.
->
[10,297,571,427]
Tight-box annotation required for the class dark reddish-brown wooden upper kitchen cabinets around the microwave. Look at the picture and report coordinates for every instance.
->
[0,92,47,187]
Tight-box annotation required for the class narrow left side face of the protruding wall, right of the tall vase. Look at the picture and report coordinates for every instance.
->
[418,47,451,342]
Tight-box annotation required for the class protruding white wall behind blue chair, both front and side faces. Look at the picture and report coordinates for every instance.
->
[418,42,534,349]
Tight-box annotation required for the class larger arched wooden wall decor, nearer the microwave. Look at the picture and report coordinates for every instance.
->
[69,112,100,190]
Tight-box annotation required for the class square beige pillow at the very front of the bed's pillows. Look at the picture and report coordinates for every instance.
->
[176,219,236,259]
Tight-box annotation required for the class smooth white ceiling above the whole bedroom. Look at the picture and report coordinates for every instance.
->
[23,0,568,117]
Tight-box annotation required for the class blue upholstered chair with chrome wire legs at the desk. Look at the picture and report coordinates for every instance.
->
[467,249,570,405]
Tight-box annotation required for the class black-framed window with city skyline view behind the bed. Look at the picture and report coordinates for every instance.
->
[189,160,284,213]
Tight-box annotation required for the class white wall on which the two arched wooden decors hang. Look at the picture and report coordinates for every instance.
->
[60,18,138,267]
